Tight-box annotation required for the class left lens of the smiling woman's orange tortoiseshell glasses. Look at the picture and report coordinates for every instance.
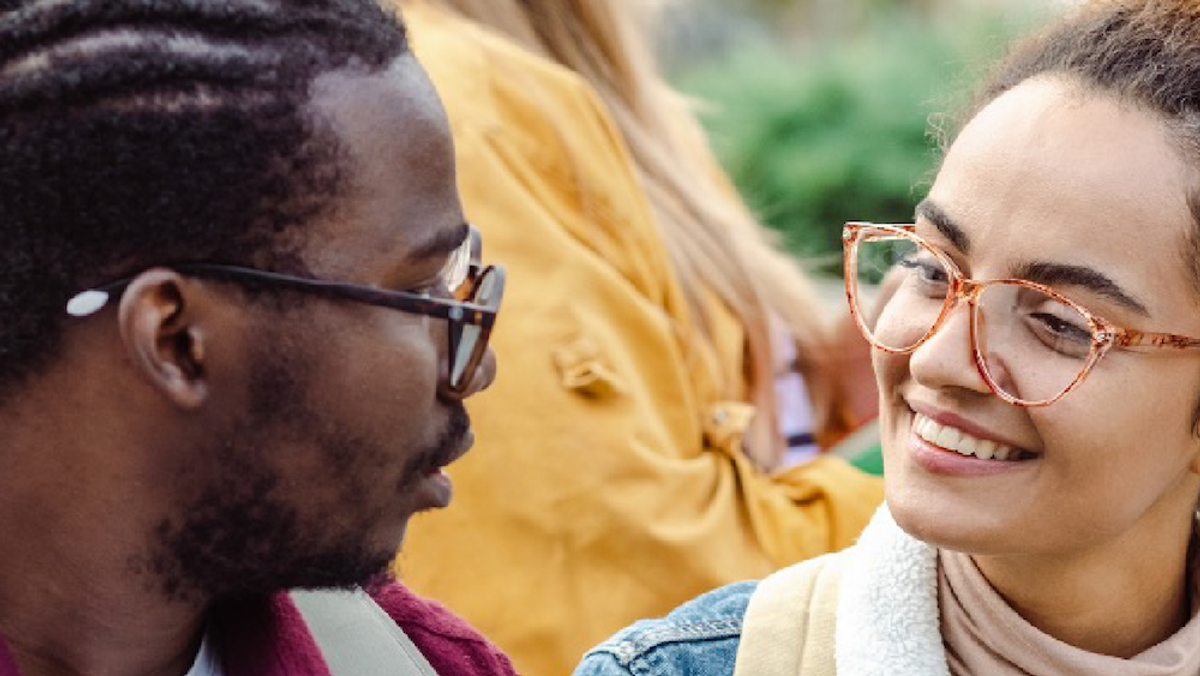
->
[848,229,952,352]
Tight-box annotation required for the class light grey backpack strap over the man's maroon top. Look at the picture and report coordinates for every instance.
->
[288,590,438,676]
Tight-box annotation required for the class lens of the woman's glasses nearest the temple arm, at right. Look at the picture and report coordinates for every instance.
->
[976,283,1094,403]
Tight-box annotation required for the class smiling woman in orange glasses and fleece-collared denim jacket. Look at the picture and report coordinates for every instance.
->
[576,0,1200,676]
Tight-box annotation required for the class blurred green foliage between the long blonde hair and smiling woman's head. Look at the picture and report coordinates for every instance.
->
[676,10,1030,271]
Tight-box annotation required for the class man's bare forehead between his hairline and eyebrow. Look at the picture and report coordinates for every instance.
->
[292,54,468,279]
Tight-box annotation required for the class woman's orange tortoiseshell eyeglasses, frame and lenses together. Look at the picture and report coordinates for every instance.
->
[842,222,1200,407]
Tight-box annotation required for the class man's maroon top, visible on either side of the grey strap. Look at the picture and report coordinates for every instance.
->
[0,582,516,676]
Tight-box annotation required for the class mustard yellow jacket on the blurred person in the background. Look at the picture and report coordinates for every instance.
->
[396,7,882,676]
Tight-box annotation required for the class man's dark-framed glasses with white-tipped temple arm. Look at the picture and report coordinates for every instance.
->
[66,228,505,395]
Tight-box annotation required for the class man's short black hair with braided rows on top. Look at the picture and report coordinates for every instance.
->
[0,0,408,401]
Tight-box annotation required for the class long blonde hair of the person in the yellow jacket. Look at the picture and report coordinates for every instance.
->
[401,0,846,468]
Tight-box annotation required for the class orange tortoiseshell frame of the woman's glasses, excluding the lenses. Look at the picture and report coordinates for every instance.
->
[841,221,1200,408]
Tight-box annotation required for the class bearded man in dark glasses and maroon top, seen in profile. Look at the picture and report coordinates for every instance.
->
[0,0,511,676]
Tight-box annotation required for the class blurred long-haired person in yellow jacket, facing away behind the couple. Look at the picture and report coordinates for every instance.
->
[396,0,882,676]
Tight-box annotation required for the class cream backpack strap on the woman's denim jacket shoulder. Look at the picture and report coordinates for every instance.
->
[733,555,845,676]
